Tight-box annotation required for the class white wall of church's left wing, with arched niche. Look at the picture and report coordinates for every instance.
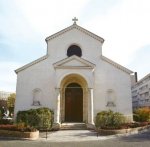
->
[15,59,56,115]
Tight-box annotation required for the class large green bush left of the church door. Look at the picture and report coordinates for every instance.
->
[17,108,53,129]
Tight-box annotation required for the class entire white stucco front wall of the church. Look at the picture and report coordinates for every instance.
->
[15,26,132,121]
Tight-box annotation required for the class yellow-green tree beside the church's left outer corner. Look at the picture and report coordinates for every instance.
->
[7,93,16,114]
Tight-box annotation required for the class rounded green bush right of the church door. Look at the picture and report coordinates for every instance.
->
[95,110,125,128]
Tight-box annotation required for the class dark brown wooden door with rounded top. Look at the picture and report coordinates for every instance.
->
[65,83,83,122]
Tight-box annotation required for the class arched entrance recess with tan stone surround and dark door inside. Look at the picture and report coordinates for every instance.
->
[60,74,88,123]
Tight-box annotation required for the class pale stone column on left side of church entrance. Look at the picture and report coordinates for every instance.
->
[52,88,60,130]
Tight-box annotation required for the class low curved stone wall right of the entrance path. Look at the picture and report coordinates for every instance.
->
[96,125,150,135]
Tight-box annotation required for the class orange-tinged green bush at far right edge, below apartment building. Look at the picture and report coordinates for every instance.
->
[133,108,150,122]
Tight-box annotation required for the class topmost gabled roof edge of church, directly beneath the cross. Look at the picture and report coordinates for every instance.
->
[45,24,104,43]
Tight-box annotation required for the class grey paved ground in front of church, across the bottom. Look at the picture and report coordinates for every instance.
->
[0,130,150,147]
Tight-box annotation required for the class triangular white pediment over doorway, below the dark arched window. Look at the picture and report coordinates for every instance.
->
[53,55,95,69]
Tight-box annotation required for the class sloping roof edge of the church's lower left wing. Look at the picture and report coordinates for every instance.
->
[15,55,48,73]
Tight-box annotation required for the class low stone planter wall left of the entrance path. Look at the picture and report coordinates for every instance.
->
[0,130,39,140]
